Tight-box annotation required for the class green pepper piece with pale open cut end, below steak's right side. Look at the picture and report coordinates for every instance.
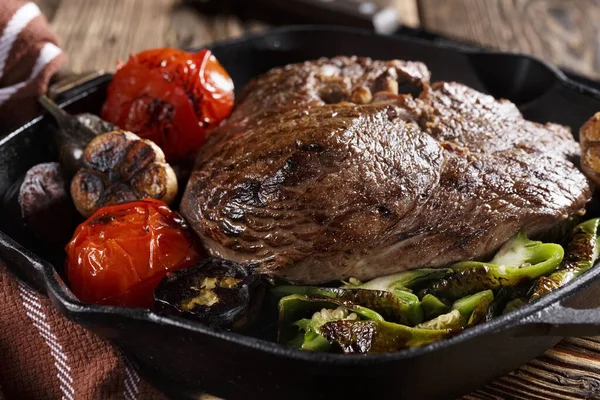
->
[423,232,564,298]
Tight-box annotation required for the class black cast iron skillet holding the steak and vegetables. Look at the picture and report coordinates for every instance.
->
[0,27,600,399]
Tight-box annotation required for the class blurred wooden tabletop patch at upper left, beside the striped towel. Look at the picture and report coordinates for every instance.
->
[45,0,244,72]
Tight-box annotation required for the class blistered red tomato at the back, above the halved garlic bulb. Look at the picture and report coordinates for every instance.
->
[102,48,233,159]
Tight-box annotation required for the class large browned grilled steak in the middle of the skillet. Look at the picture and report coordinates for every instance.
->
[181,57,591,284]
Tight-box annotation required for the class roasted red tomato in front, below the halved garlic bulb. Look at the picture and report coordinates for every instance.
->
[66,199,199,308]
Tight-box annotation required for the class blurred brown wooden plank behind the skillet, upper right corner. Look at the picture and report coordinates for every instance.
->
[419,0,600,78]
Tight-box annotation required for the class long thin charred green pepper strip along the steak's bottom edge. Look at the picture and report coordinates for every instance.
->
[271,285,423,325]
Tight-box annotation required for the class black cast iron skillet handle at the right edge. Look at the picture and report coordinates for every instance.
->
[517,303,600,337]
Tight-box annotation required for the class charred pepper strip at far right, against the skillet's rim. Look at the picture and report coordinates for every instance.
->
[530,218,600,301]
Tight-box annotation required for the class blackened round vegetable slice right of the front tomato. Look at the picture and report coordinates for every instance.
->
[154,258,264,331]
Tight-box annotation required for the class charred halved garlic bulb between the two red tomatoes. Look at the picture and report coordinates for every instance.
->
[71,130,177,217]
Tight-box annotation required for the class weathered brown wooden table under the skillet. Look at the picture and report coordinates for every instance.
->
[34,0,600,400]
